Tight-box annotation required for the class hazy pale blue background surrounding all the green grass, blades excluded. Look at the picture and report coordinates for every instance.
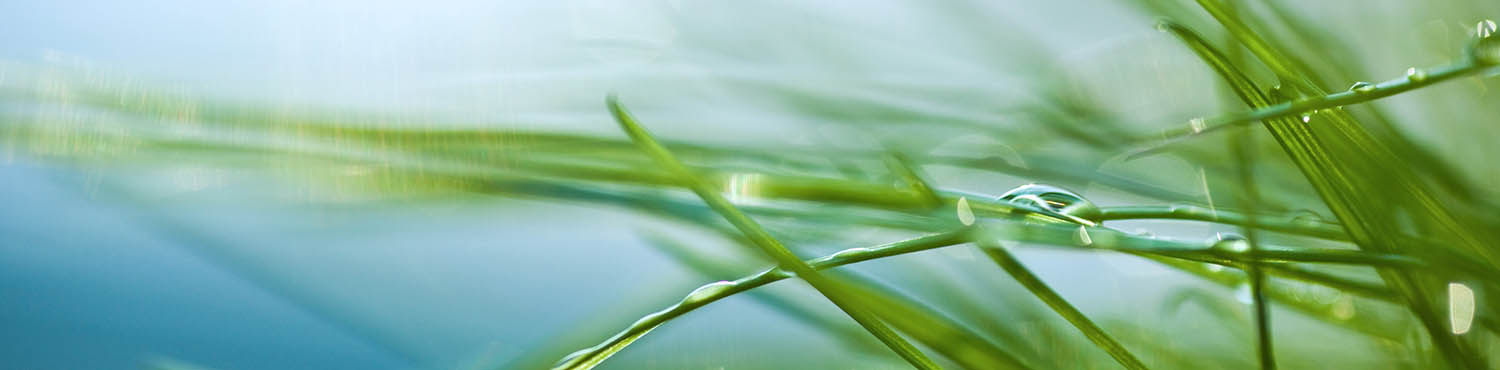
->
[0,0,1500,369]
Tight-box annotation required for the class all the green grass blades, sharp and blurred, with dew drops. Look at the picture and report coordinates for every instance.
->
[0,0,1500,369]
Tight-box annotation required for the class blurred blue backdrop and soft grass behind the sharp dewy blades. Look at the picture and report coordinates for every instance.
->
[0,0,1500,369]
